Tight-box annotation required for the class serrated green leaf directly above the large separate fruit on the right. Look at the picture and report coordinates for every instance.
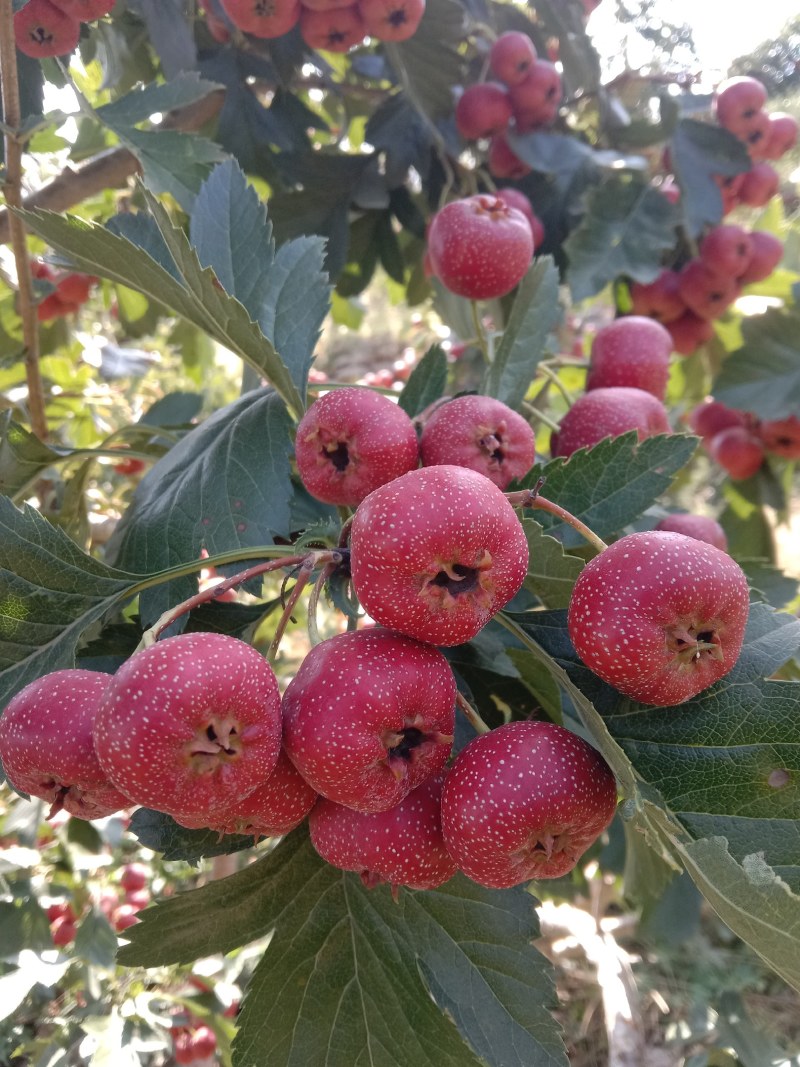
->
[525,431,697,548]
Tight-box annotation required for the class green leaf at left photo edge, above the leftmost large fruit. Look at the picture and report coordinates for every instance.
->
[0,496,140,707]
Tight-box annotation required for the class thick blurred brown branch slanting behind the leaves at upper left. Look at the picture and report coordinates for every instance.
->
[0,89,225,244]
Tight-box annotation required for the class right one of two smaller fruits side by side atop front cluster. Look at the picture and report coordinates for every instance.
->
[419,396,535,489]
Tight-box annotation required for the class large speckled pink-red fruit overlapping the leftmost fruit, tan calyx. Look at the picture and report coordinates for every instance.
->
[95,633,281,817]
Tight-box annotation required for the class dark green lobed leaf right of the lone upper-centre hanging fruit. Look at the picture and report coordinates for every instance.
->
[564,175,678,301]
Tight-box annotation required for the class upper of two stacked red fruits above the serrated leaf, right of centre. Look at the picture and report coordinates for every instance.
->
[586,315,672,400]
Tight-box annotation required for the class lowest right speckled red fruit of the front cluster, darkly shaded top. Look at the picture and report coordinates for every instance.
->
[442,722,617,889]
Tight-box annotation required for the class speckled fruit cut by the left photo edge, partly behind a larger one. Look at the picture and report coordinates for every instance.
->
[0,669,131,819]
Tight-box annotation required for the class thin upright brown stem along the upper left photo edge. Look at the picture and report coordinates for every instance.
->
[0,0,47,441]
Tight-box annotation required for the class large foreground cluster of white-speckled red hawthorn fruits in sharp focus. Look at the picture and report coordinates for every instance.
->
[0,375,748,889]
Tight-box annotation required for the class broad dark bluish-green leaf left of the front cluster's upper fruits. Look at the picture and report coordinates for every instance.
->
[110,388,292,625]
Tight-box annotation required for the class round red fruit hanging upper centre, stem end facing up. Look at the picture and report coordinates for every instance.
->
[428,193,533,300]
